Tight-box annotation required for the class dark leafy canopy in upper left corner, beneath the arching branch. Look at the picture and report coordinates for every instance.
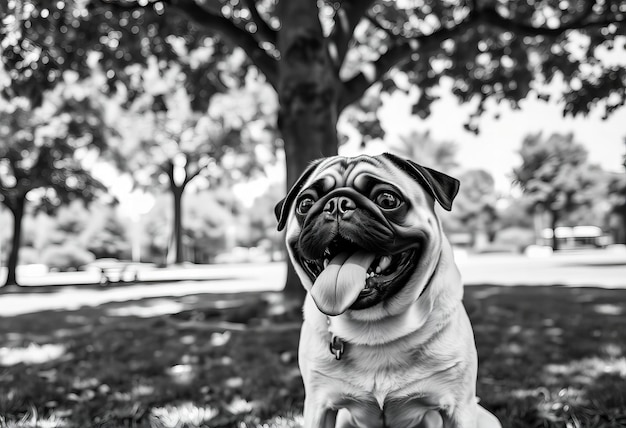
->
[0,0,237,109]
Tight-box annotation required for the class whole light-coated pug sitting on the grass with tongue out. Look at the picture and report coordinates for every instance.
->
[276,153,500,428]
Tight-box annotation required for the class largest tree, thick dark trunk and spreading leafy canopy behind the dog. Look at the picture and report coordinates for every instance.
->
[3,0,626,289]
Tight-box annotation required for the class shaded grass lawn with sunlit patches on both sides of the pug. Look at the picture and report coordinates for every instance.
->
[0,286,626,428]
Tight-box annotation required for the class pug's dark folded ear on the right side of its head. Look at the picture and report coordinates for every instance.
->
[382,153,460,211]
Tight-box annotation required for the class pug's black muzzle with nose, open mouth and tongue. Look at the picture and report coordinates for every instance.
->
[293,189,422,316]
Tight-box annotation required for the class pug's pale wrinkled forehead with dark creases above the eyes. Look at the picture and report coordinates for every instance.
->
[304,155,422,194]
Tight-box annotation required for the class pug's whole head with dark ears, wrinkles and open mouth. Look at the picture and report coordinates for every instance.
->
[276,154,459,318]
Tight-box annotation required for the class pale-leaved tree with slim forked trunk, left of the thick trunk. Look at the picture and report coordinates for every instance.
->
[118,58,275,263]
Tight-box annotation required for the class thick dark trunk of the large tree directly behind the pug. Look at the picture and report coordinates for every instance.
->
[278,1,340,299]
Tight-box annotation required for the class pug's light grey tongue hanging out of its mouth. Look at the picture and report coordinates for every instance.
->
[311,251,376,316]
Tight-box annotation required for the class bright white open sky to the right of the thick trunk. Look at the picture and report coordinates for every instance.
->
[340,77,626,192]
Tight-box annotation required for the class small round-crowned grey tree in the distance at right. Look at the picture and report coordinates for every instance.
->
[513,133,604,250]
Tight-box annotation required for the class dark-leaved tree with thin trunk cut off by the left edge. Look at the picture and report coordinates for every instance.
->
[0,75,107,286]
